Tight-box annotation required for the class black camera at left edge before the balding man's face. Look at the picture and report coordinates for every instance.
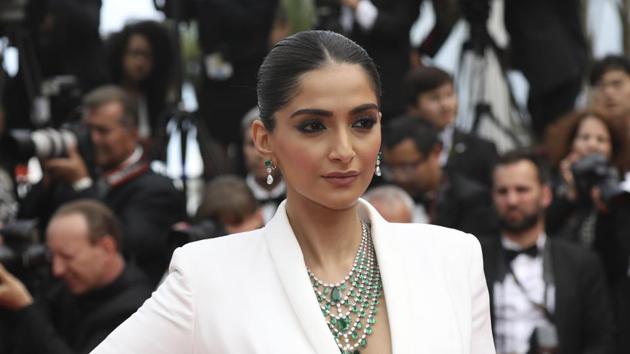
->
[0,220,49,273]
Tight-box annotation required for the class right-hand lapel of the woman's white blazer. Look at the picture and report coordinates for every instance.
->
[360,200,420,353]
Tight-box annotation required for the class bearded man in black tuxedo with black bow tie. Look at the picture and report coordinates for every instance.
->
[482,151,613,354]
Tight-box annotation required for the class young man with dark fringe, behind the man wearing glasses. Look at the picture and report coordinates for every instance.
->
[404,66,497,187]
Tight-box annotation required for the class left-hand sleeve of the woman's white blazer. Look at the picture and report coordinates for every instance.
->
[92,249,194,354]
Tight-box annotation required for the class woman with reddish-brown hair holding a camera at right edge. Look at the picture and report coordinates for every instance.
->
[547,113,630,353]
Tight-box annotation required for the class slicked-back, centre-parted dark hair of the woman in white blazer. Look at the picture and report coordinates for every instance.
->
[256,31,381,131]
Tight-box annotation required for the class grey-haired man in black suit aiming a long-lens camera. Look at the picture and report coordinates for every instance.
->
[18,86,186,285]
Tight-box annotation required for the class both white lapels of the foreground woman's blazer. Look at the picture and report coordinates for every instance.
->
[264,199,417,353]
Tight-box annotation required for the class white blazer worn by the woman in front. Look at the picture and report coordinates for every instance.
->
[92,200,495,354]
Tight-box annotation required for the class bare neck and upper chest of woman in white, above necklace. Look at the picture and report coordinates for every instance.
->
[287,195,361,283]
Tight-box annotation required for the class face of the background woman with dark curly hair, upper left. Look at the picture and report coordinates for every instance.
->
[123,33,153,83]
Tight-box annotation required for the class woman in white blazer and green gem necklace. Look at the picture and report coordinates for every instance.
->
[94,31,494,354]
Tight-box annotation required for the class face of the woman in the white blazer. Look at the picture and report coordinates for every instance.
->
[267,63,381,209]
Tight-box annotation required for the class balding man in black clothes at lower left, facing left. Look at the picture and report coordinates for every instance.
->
[0,200,151,354]
